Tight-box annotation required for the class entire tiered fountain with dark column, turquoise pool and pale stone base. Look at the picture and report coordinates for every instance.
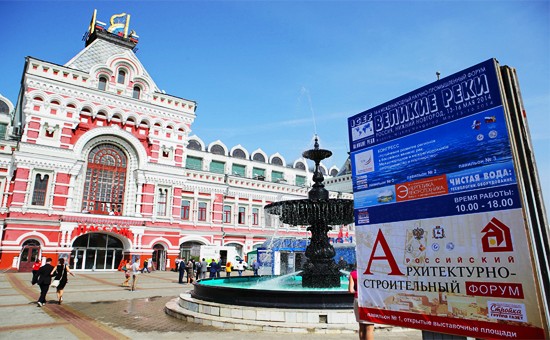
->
[165,137,357,332]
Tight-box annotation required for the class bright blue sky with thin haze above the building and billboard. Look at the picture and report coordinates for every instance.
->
[0,0,550,210]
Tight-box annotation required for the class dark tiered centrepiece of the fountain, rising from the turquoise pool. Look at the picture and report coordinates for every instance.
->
[265,137,353,288]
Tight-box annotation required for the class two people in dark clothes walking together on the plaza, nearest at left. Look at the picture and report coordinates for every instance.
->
[31,257,75,307]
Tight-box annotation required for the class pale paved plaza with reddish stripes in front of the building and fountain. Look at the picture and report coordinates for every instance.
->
[0,272,422,340]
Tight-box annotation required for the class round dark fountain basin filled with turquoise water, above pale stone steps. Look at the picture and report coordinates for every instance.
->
[191,276,353,310]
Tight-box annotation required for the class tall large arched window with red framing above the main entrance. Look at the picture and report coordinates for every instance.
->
[82,144,127,215]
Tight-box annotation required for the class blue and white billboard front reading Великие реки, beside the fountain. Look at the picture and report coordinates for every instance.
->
[348,59,547,339]
